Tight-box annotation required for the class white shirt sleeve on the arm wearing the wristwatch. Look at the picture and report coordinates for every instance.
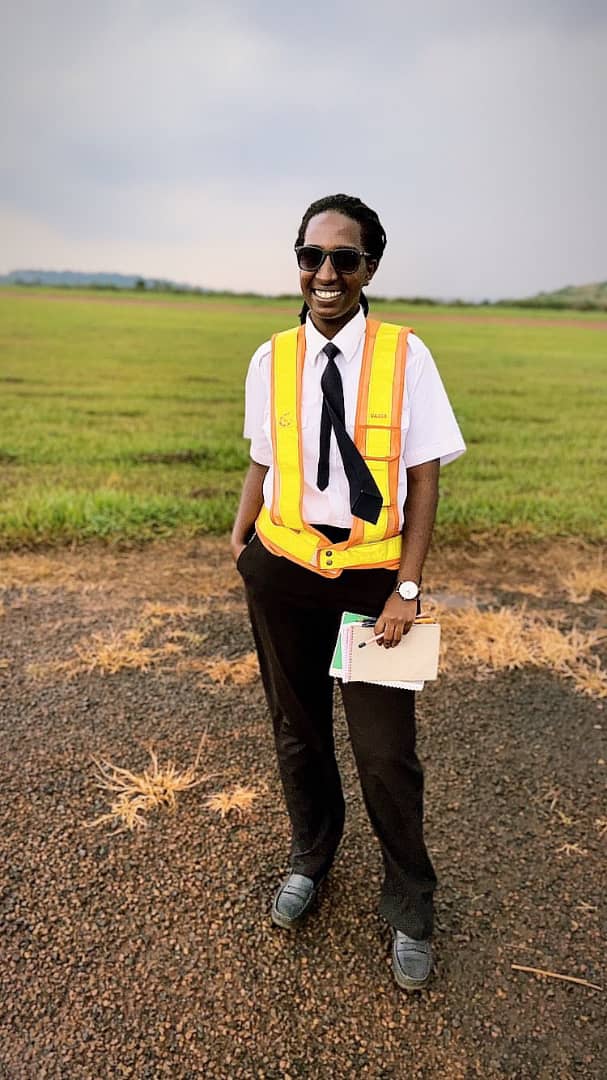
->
[404,334,466,469]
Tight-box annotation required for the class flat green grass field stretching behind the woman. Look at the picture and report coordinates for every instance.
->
[0,289,607,549]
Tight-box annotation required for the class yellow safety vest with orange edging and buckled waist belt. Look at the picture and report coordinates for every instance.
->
[255,319,410,578]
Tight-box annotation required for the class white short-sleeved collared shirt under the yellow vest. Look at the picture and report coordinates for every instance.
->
[244,308,466,528]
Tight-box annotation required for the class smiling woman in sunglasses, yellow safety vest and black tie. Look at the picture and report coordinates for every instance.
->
[231,194,464,989]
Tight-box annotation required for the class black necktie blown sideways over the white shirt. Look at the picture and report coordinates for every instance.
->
[316,341,383,525]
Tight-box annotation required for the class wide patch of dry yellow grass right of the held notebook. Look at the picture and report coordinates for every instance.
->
[440,607,607,697]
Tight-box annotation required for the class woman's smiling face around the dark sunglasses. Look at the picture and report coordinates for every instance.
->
[299,210,377,338]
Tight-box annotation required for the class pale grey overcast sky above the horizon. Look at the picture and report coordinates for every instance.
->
[0,0,607,299]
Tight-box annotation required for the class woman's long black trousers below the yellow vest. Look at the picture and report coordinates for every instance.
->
[238,537,436,939]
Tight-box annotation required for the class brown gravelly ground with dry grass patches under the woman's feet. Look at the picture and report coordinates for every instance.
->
[0,540,607,1080]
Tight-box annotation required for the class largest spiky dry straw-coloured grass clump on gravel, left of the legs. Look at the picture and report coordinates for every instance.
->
[86,735,211,833]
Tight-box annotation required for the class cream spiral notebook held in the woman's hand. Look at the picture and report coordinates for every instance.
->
[331,611,441,690]
